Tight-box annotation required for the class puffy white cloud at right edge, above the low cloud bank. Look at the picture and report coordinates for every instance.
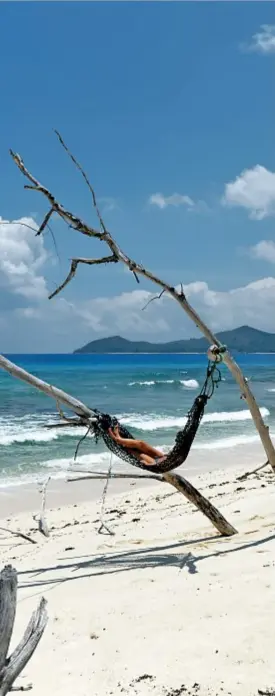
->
[222,164,275,220]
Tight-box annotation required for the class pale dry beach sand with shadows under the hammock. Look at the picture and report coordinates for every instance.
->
[0,466,275,696]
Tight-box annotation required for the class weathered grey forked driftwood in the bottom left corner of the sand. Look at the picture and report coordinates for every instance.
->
[0,565,48,696]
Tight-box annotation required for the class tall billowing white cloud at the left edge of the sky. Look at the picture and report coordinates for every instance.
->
[0,217,47,300]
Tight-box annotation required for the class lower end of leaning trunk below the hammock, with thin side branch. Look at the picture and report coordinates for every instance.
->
[67,468,238,536]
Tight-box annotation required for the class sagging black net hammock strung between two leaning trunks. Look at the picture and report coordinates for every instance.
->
[91,362,221,474]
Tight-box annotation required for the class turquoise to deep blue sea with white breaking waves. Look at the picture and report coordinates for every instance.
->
[0,355,275,486]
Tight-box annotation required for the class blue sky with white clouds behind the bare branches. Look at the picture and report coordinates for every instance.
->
[0,2,275,352]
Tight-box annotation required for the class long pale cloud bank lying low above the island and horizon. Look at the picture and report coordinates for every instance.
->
[8,277,275,352]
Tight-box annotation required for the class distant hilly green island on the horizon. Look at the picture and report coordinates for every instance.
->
[74,326,275,354]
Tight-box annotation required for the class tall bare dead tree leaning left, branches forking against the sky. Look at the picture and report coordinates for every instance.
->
[10,131,275,472]
